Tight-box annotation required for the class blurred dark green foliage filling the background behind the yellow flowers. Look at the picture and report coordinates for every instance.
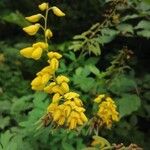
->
[0,0,150,150]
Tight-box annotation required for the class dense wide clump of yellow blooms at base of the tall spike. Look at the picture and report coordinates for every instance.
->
[47,92,88,129]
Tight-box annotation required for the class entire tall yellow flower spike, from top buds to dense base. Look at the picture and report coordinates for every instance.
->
[20,3,88,129]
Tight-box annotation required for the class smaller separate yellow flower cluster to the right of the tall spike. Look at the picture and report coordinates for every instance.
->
[94,94,119,128]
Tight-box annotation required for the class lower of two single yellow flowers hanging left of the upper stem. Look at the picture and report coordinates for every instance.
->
[23,23,40,36]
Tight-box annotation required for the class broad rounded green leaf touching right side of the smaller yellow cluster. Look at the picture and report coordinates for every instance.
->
[117,94,141,117]
